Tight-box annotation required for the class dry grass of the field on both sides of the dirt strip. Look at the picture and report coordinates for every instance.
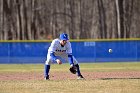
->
[0,62,140,93]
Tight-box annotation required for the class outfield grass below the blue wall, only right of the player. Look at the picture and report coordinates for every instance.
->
[80,62,140,72]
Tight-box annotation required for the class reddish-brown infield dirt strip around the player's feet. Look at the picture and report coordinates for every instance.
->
[0,71,140,80]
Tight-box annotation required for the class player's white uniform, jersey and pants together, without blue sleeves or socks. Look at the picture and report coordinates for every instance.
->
[45,39,78,65]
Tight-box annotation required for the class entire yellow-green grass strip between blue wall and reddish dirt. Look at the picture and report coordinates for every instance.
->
[0,62,140,73]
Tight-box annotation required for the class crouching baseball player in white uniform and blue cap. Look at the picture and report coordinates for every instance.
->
[44,33,84,80]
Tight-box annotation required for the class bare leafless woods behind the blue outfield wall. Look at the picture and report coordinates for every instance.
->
[0,0,140,40]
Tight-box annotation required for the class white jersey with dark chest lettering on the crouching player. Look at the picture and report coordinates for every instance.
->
[48,39,72,56]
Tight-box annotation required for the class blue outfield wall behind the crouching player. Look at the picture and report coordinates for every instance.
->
[0,40,140,63]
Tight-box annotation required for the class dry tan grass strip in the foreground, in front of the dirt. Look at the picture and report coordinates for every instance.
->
[0,79,140,93]
